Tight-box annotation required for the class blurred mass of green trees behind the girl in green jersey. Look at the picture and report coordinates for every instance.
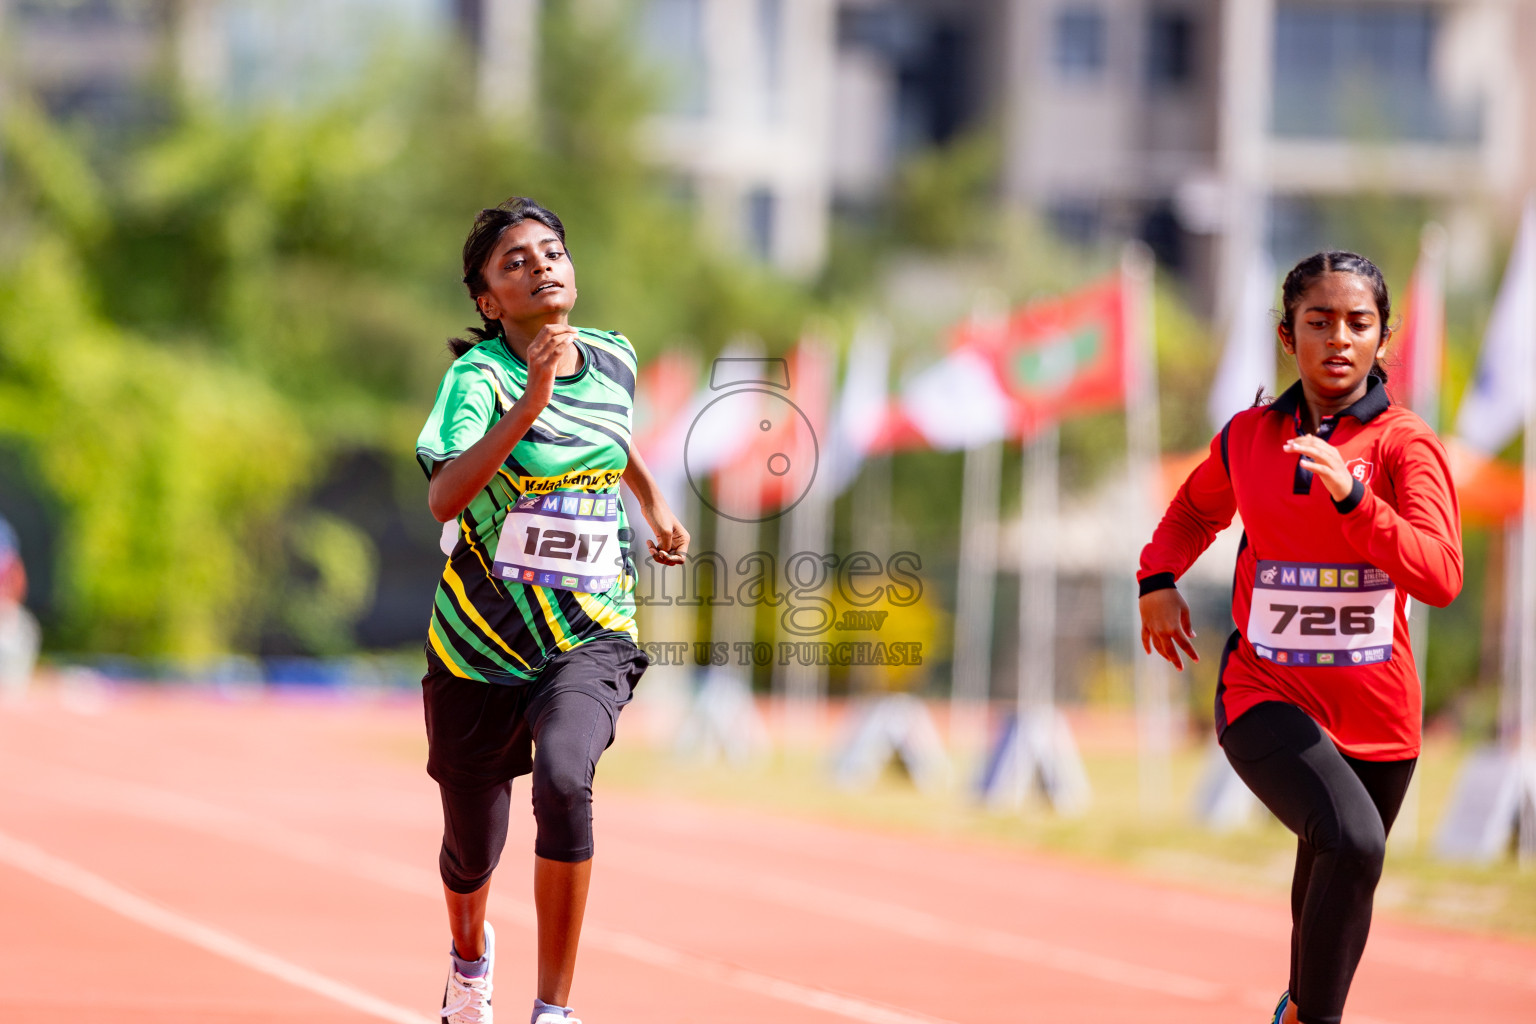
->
[0,10,809,657]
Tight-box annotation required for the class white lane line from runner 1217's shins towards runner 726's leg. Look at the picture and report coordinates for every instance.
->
[611,840,1233,1003]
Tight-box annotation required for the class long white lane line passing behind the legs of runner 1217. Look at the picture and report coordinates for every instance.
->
[0,771,955,1024]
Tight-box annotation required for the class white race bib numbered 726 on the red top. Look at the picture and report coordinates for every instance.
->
[1247,560,1396,668]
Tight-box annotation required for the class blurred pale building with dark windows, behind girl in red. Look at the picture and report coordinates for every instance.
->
[1000,0,1536,315]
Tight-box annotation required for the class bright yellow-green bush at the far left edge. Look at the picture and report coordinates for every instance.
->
[0,235,309,656]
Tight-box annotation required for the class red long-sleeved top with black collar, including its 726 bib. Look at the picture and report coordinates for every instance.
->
[1137,379,1462,761]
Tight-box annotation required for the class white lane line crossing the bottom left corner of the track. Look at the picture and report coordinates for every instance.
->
[0,832,432,1024]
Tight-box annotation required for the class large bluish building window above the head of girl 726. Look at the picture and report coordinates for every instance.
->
[1273,0,1482,144]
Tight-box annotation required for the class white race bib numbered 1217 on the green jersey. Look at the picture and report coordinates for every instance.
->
[492,491,624,594]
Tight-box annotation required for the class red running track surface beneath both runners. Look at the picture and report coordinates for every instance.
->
[0,691,1536,1024]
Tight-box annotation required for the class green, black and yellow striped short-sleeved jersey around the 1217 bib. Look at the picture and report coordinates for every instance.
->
[416,327,637,683]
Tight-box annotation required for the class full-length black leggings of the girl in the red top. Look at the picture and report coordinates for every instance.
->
[1221,702,1416,1024]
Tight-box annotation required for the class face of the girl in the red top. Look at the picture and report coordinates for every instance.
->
[1279,272,1389,399]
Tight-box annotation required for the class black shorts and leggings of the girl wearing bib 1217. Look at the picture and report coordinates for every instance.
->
[422,639,648,894]
